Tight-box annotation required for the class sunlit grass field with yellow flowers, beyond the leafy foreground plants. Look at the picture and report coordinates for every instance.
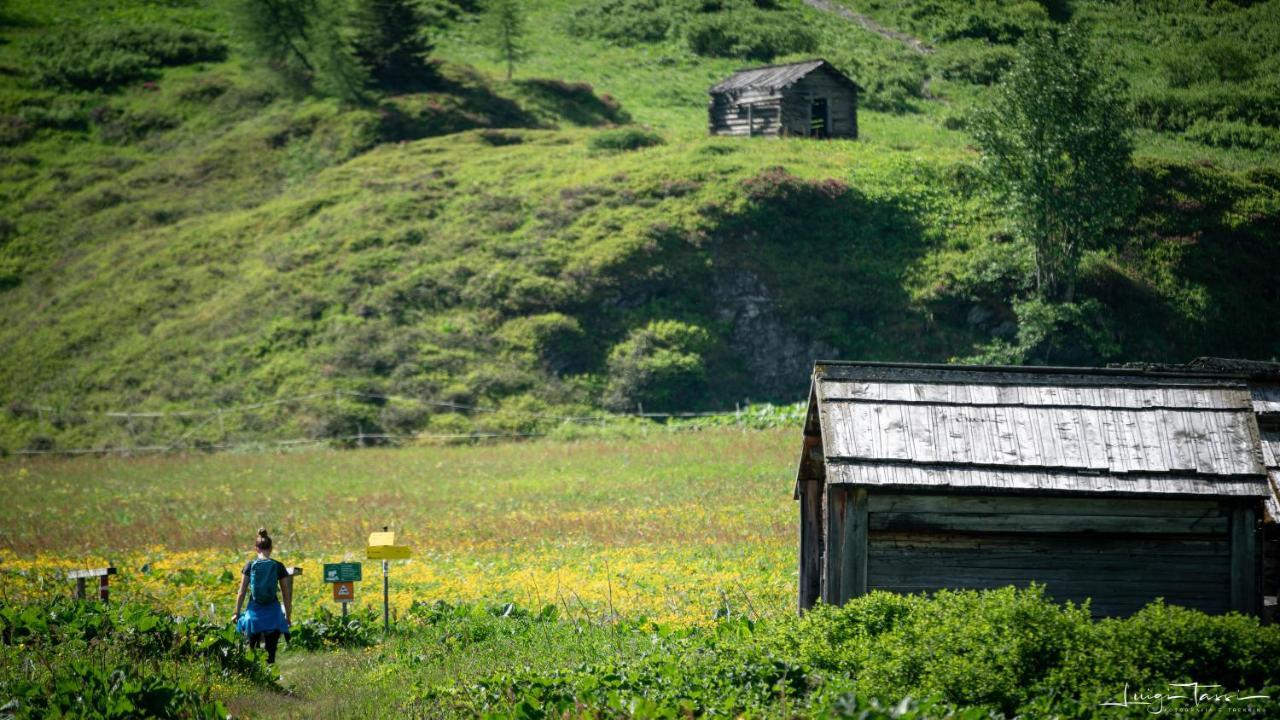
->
[0,429,796,624]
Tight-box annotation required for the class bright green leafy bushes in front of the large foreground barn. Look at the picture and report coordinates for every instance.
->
[455,585,1280,719]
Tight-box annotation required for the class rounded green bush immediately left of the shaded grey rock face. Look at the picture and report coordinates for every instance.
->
[603,320,712,410]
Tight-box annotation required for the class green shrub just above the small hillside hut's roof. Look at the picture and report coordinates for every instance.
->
[685,9,818,60]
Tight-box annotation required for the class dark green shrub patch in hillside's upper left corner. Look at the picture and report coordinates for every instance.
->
[28,26,227,90]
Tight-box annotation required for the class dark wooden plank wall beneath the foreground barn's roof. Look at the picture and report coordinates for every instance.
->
[823,486,1258,616]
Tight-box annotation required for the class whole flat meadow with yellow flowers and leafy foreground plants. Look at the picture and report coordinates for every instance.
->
[0,428,1280,720]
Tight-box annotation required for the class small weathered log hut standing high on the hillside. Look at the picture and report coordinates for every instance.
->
[708,59,861,138]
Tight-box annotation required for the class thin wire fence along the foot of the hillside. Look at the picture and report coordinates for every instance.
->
[12,389,803,456]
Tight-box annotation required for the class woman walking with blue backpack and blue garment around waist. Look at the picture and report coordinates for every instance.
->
[234,528,293,664]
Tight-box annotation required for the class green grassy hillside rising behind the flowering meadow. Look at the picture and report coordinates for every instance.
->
[0,0,1280,450]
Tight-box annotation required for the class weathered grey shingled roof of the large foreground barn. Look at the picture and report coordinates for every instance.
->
[800,363,1280,497]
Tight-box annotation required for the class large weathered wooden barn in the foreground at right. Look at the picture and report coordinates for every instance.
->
[796,363,1280,616]
